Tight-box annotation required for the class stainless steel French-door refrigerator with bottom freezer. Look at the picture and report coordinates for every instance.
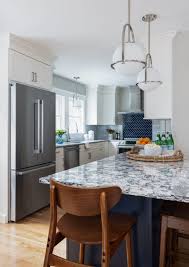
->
[10,83,55,221]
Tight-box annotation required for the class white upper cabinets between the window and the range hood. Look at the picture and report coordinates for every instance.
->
[86,86,117,125]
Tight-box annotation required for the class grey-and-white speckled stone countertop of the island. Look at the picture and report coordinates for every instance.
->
[40,153,189,203]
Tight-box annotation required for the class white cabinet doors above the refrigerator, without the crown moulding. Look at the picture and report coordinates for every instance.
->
[9,49,53,90]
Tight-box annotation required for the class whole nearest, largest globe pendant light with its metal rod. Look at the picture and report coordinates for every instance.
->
[111,0,145,75]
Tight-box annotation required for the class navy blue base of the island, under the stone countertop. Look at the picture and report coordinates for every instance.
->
[67,195,162,267]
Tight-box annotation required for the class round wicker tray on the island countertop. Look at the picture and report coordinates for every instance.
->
[127,150,184,162]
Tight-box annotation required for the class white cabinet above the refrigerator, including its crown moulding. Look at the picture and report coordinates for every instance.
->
[9,35,53,90]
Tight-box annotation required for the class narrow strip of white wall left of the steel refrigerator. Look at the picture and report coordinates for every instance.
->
[0,34,9,223]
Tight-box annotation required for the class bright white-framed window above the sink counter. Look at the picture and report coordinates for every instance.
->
[55,90,85,134]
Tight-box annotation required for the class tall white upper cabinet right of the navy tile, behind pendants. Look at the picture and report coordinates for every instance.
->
[144,33,174,119]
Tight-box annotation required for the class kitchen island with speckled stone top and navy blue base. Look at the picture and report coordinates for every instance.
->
[40,154,189,267]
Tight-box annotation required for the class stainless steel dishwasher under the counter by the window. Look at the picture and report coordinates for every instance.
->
[64,145,79,170]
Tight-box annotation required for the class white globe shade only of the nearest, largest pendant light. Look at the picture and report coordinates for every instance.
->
[112,42,145,75]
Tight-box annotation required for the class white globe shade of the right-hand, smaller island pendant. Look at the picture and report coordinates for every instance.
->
[137,67,162,91]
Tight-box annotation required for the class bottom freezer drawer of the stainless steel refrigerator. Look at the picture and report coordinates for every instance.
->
[11,163,55,221]
